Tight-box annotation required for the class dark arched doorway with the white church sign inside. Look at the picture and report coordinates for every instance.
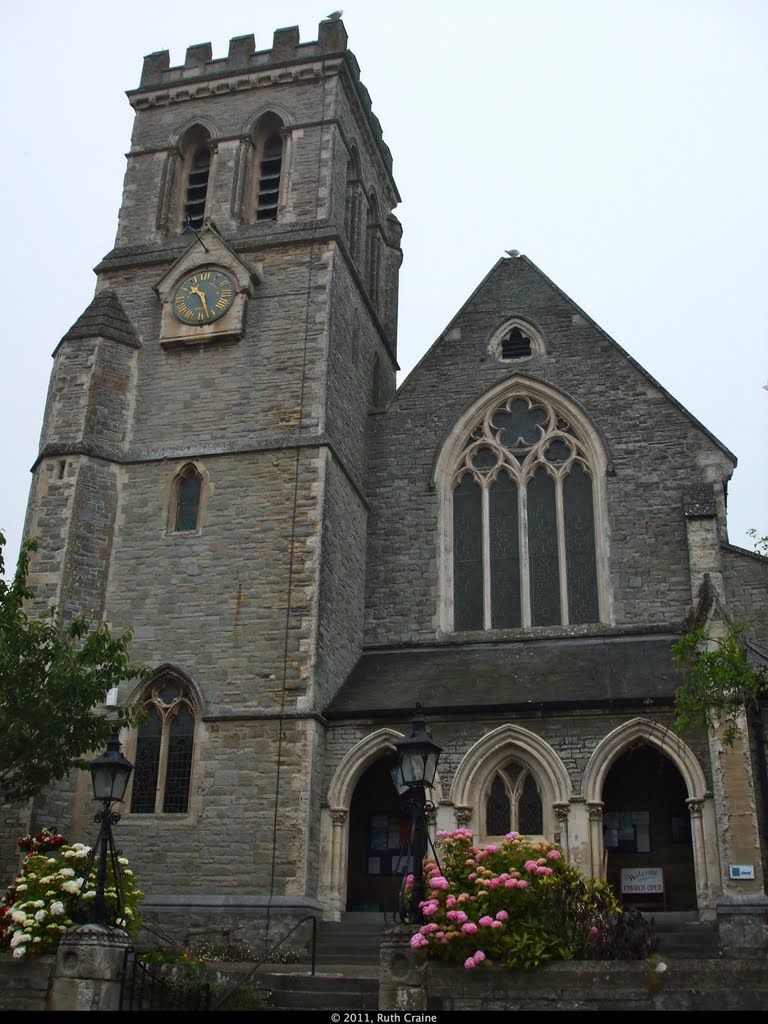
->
[602,743,696,910]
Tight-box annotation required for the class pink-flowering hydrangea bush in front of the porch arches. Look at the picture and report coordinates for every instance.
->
[409,828,621,970]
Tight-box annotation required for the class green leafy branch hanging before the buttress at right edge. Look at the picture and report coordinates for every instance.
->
[672,624,766,746]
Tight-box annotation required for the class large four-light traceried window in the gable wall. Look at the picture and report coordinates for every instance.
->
[445,386,600,630]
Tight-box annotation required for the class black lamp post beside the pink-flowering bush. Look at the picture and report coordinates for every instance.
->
[392,705,442,925]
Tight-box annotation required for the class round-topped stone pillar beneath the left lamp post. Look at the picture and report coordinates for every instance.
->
[46,925,131,1013]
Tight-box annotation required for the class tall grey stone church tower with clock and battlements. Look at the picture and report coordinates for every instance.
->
[20,22,401,925]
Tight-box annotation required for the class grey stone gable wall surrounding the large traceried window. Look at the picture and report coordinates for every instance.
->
[367,257,732,644]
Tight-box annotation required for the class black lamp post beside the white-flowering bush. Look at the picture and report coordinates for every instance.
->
[81,732,133,925]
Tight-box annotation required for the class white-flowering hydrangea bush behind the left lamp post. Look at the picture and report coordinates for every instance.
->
[0,828,143,959]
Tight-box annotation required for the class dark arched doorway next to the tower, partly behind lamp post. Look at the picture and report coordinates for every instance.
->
[346,756,411,912]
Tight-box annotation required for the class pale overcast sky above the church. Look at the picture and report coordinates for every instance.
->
[0,0,768,577]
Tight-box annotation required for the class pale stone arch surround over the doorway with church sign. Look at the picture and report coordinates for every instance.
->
[583,718,719,910]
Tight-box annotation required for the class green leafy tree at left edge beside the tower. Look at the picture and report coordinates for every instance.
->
[0,534,151,803]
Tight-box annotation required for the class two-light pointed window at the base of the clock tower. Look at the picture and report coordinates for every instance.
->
[131,674,196,814]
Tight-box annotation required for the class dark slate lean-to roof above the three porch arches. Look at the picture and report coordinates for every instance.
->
[326,635,679,719]
